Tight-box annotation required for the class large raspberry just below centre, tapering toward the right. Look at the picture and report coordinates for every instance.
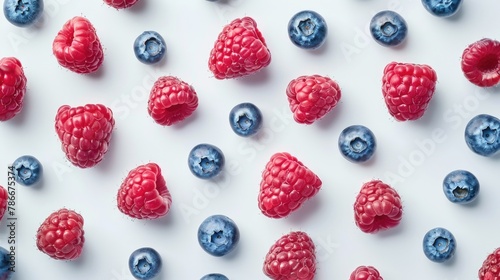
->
[258,153,322,218]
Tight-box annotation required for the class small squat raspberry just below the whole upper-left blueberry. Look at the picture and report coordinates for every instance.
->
[148,76,198,126]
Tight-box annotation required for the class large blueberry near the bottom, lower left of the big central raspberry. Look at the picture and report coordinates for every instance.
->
[198,215,240,257]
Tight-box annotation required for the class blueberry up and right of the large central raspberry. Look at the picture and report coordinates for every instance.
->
[338,125,377,162]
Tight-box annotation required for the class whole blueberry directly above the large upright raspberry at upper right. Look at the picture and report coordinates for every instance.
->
[370,11,408,46]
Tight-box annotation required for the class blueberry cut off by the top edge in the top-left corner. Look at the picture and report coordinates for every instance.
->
[3,0,43,27]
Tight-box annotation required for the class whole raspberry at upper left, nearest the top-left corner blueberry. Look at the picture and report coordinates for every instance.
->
[52,16,104,74]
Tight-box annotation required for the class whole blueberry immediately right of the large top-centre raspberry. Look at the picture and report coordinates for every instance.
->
[288,10,328,49]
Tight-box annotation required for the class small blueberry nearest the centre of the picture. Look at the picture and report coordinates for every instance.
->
[229,103,262,137]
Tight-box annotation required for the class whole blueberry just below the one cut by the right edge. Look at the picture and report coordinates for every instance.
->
[443,170,479,204]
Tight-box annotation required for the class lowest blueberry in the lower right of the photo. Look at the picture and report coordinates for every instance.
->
[423,227,457,263]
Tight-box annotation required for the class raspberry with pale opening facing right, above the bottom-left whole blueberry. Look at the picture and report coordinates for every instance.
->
[117,163,172,219]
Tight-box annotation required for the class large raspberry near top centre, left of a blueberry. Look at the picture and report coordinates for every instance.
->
[208,17,271,79]
